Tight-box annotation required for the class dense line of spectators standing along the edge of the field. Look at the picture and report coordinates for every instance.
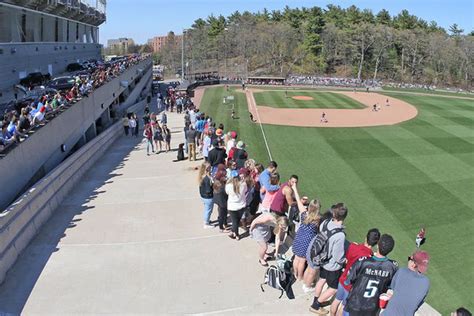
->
[193,112,470,316]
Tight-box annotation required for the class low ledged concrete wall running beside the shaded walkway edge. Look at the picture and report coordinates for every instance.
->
[0,116,128,283]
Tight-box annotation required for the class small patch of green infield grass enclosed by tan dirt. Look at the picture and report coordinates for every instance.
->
[254,91,365,109]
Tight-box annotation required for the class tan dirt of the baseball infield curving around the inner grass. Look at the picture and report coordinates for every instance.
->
[246,89,418,127]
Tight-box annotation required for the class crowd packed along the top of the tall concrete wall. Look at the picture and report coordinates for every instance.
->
[0,55,147,156]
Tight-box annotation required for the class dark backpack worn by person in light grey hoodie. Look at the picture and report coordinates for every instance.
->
[306,219,345,267]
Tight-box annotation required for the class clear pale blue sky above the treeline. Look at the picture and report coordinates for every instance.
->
[99,0,474,44]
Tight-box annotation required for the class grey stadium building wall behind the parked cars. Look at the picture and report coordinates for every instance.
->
[0,42,101,102]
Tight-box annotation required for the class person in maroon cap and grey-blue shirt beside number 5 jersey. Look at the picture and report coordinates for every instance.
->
[381,250,430,316]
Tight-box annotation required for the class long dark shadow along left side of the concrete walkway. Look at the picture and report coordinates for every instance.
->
[0,136,142,315]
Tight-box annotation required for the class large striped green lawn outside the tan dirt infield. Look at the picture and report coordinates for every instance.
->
[201,87,474,315]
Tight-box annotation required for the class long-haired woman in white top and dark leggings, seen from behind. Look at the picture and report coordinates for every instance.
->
[225,174,247,240]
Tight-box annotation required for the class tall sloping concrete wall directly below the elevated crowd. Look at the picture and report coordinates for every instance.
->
[0,59,152,209]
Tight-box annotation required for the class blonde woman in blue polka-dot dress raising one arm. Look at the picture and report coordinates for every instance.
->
[292,185,321,292]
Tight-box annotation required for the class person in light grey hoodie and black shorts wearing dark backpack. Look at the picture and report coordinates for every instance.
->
[309,203,348,315]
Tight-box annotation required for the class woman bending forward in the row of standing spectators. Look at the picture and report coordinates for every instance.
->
[250,213,288,267]
